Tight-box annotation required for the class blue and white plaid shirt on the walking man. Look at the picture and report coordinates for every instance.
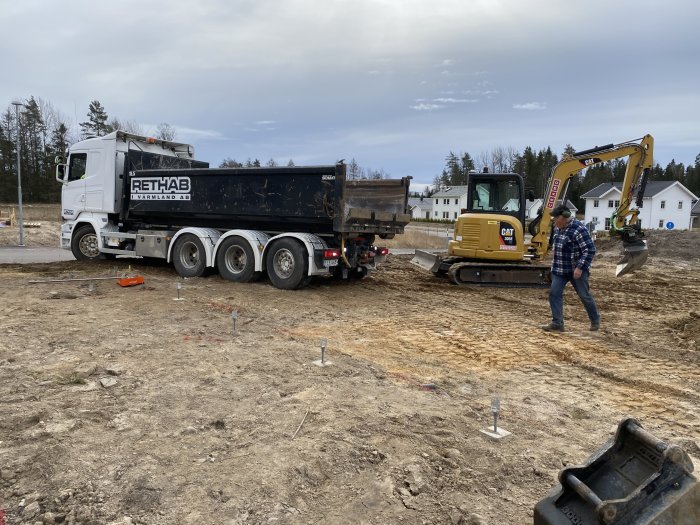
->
[552,219,595,276]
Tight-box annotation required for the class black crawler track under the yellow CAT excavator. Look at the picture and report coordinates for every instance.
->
[447,262,552,288]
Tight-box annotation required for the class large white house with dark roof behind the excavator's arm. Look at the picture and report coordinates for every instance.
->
[581,180,698,231]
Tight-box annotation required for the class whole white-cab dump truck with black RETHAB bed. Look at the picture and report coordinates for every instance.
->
[56,131,410,289]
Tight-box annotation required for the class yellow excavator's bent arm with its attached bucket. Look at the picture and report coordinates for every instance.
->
[528,135,654,276]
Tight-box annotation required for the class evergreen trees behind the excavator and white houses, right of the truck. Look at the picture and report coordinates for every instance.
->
[430,146,700,209]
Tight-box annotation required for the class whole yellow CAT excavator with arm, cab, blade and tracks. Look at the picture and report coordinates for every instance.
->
[411,135,654,286]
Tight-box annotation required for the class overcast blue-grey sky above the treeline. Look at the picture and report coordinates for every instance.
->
[0,0,700,183]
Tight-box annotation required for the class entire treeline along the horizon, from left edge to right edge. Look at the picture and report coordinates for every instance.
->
[0,97,700,207]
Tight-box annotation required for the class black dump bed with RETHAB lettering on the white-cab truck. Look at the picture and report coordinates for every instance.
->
[121,164,410,234]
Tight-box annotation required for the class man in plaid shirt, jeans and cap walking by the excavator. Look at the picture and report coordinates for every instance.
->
[542,205,600,332]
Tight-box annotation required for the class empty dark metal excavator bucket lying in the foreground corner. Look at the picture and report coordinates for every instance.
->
[534,418,700,525]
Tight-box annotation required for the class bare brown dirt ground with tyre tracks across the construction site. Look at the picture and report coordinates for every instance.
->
[0,222,700,524]
